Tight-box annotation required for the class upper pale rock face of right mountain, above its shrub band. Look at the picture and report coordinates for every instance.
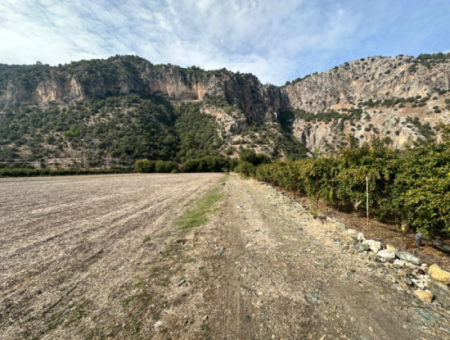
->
[284,56,450,112]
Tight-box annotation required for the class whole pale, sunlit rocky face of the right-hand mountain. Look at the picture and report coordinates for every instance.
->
[282,56,450,150]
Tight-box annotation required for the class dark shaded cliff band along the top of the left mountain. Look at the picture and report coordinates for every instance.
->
[0,56,285,120]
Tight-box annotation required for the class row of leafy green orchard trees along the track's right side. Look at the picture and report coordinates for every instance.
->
[249,125,450,235]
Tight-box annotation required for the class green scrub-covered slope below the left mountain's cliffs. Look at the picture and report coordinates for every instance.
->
[0,94,222,167]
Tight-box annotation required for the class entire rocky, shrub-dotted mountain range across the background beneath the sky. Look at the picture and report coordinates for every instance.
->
[0,54,450,167]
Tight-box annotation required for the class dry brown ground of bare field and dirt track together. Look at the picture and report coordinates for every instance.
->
[0,174,450,340]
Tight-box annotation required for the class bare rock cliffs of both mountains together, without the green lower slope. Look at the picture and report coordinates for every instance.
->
[0,56,450,151]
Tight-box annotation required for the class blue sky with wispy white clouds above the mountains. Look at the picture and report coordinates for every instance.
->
[0,0,450,85]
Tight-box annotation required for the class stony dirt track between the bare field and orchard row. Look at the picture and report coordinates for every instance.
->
[201,178,445,340]
